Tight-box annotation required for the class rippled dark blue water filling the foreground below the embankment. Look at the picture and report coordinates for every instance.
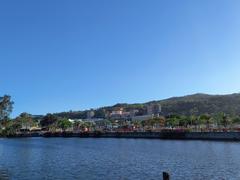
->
[0,138,240,180]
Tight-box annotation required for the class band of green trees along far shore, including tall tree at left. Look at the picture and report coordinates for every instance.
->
[0,95,240,135]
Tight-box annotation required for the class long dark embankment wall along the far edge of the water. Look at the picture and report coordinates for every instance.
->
[2,132,240,141]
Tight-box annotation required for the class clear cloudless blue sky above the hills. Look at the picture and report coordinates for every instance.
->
[0,0,240,116]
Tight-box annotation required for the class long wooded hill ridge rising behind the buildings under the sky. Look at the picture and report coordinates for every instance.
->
[52,93,240,118]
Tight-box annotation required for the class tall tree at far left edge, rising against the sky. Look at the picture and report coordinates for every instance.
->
[0,95,14,120]
